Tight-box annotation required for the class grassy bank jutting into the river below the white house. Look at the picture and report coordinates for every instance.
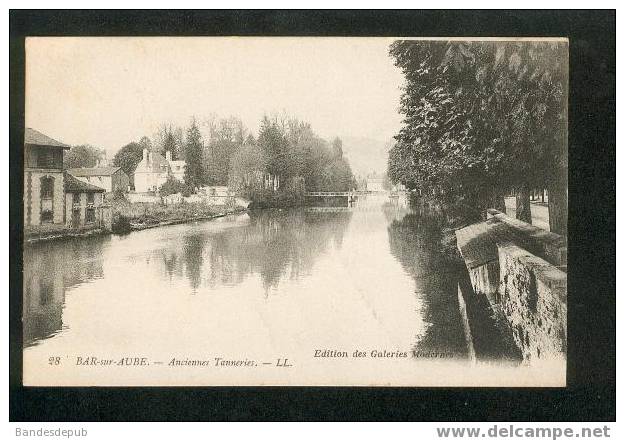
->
[110,199,244,233]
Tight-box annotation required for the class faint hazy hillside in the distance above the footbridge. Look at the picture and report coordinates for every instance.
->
[341,136,391,176]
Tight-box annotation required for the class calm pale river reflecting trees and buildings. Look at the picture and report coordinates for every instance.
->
[23,194,467,385]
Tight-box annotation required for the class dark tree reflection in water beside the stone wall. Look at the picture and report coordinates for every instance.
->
[384,206,468,357]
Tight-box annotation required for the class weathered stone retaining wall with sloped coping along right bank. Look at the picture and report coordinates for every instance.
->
[456,210,567,362]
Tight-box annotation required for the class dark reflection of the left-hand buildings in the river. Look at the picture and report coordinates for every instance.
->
[22,237,109,346]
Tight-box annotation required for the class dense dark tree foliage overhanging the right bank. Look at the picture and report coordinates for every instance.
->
[388,41,568,232]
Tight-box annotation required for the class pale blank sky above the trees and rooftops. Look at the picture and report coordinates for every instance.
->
[26,37,403,157]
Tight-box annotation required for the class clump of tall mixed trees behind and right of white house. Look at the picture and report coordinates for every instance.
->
[115,116,357,206]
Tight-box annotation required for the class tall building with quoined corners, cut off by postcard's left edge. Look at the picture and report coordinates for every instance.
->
[24,128,70,223]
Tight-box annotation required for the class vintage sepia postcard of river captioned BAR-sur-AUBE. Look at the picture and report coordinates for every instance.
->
[22,37,568,387]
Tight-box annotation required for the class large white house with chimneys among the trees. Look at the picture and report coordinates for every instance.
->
[134,149,186,193]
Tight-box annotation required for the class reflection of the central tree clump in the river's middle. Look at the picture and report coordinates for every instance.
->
[155,209,352,293]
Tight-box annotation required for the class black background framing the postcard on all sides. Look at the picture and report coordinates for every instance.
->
[9,10,616,421]
